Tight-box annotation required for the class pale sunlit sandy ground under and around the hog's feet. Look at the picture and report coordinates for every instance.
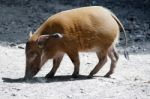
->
[0,46,150,99]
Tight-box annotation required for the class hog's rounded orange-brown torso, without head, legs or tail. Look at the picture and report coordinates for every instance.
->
[37,6,119,51]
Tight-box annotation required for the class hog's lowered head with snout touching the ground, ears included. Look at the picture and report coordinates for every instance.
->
[24,33,62,80]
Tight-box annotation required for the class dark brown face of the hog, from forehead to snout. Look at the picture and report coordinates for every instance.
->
[25,41,41,79]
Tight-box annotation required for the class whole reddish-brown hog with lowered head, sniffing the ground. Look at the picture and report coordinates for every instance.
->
[25,6,128,79]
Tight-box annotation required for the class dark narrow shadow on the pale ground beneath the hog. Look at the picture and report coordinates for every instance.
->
[2,75,94,83]
